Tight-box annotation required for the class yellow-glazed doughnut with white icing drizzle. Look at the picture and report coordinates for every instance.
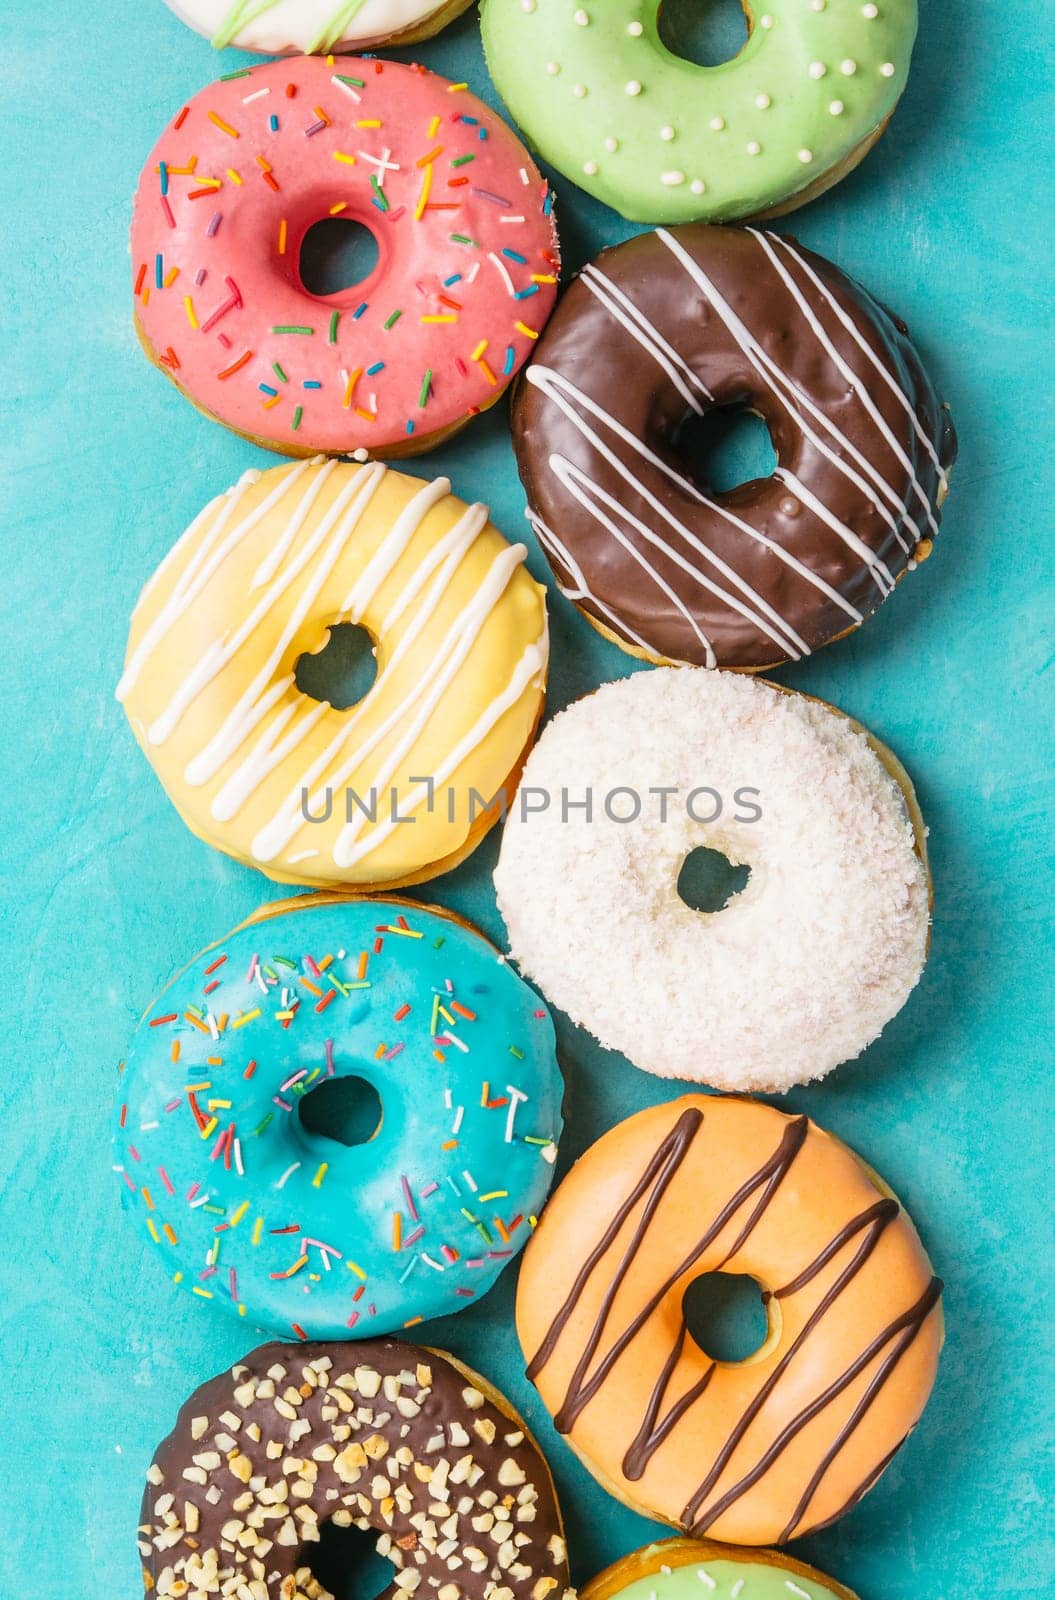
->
[117,459,549,888]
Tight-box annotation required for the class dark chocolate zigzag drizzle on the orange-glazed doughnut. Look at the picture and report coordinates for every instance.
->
[528,1106,941,1541]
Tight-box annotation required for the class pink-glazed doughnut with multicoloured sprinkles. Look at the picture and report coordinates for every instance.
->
[131,56,559,456]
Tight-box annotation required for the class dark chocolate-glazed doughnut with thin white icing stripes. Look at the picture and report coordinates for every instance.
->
[512,226,956,670]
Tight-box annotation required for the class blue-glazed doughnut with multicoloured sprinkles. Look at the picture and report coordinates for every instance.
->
[114,896,562,1339]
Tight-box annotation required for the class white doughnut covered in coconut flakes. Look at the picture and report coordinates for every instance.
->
[495,669,930,1091]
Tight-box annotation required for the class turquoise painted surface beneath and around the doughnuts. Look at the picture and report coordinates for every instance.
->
[0,0,1055,1600]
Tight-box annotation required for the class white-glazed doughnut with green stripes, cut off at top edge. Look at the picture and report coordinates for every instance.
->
[165,0,471,56]
